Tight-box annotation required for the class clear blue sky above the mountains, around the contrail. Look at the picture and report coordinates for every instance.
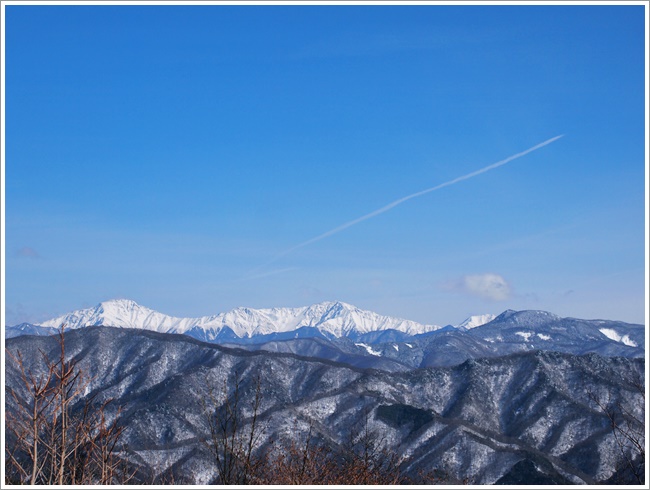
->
[3,5,645,325]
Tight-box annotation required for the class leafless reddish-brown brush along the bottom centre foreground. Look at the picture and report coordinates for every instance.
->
[197,374,407,485]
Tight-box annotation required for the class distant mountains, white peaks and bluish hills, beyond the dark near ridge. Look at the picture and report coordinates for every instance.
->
[5,300,645,364]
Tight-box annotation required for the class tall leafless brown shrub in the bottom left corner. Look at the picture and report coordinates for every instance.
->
[5,325,130,485]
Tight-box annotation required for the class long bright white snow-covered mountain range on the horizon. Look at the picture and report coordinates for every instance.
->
[35,299,441,340]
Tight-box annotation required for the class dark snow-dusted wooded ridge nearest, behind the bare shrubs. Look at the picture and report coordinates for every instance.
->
[6,327,645,484]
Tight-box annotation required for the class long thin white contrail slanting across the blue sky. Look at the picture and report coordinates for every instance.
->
[256,134,564,265]
